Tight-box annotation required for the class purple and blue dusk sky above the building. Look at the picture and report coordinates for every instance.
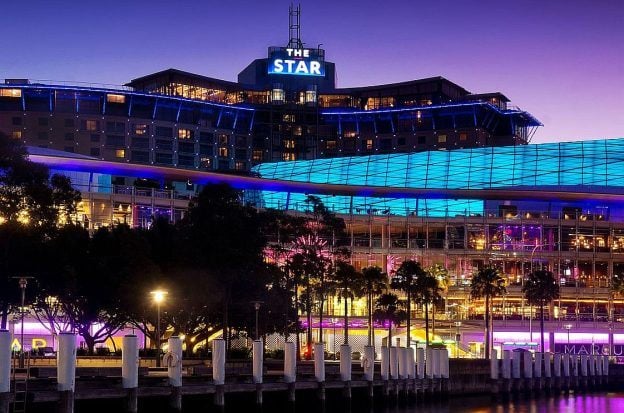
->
[0,0,624,142]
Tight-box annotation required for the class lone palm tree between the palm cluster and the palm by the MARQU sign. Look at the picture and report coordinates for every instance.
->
[470,267,507,359]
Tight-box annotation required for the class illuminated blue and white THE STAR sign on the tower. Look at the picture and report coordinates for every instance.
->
[269,47,325,76]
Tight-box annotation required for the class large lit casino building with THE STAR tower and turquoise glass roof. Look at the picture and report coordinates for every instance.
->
[0,8,624,355]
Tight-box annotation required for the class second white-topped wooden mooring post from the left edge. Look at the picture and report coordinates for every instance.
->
[56,333,76,413]
